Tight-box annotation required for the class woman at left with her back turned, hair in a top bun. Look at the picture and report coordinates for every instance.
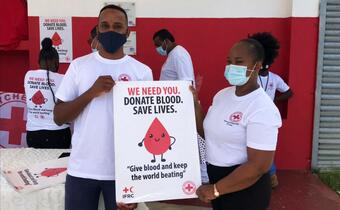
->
[24,38,71,148]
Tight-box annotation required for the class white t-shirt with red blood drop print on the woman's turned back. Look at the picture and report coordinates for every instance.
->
[24,69,69,131]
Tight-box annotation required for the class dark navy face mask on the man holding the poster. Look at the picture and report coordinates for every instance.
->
[98,31,126,53]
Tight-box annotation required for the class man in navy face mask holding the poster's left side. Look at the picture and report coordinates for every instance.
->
[54,5,153,210]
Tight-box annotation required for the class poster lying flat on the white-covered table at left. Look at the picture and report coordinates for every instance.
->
[2,157,68,193]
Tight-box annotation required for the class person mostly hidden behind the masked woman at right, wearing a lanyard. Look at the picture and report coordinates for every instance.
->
[249,32,293,188]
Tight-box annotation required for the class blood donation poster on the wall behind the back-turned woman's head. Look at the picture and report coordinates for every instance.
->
[39,17,73,63]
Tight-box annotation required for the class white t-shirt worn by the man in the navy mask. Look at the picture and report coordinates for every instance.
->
[56,52,153,180]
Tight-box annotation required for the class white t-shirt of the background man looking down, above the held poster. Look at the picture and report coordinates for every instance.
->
[159,45,195,81]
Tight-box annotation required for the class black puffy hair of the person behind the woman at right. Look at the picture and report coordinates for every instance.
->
[248,32,280,69]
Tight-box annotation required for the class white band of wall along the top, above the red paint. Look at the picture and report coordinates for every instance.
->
[27,0,319,18]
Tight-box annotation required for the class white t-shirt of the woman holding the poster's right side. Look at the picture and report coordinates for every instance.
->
[203,86,281,167]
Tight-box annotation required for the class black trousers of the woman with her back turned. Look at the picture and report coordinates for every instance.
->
[26,128,71,149]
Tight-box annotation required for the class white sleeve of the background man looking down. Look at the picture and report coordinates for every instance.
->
[173,55,195,81]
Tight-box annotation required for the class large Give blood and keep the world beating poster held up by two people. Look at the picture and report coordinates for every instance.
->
[113,81,201,203]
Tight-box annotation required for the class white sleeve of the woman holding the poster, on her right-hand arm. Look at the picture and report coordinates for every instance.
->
[247,109,281,151]
